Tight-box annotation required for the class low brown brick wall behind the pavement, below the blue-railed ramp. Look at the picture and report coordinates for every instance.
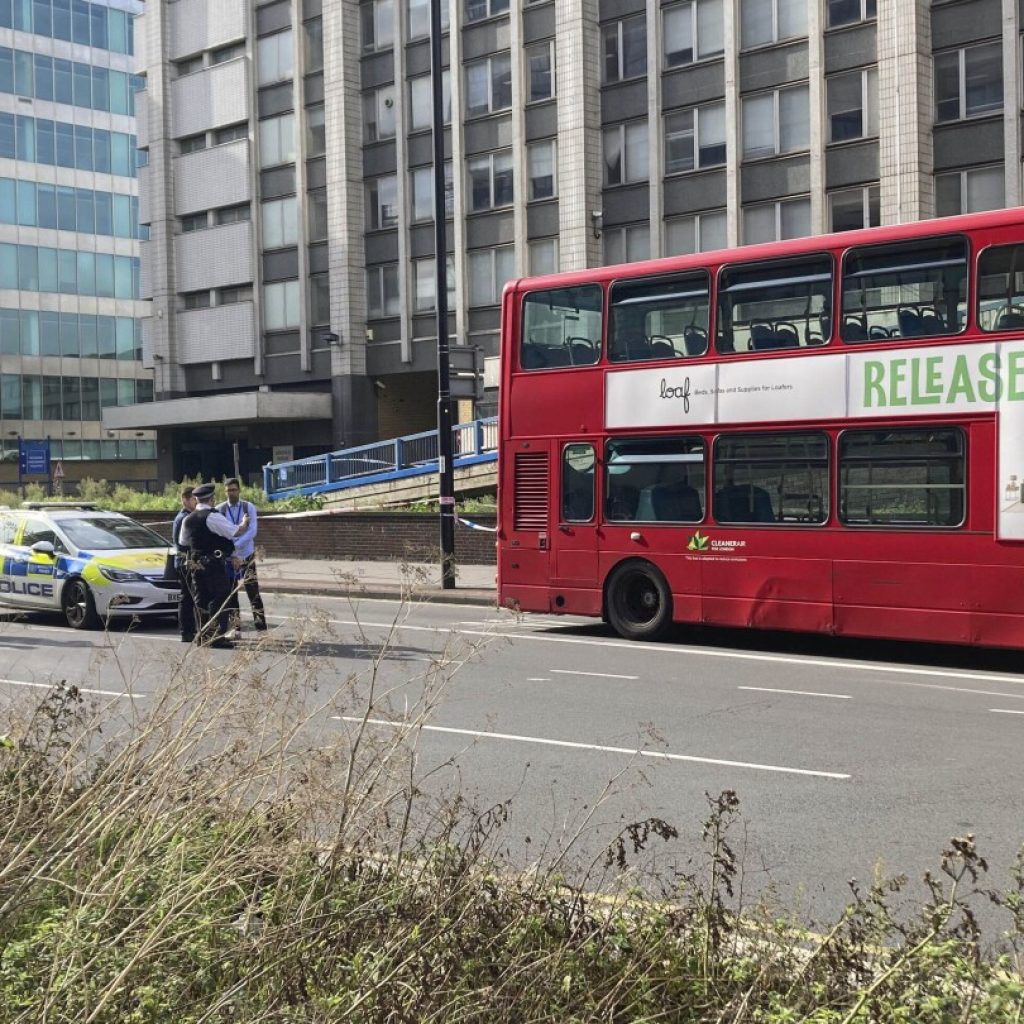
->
[136,512,496,565]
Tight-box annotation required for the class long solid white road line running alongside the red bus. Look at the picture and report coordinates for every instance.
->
[280,615,1024,696]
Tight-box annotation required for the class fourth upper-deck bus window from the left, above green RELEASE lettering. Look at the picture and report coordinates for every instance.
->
[840,238,968,342]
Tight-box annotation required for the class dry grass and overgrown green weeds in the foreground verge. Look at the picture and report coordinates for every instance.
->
[0,622,1024,1024]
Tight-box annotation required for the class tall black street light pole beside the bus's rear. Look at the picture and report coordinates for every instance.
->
[430,0,455,590]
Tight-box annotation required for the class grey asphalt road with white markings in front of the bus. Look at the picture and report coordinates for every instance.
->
[0,594,1024,926]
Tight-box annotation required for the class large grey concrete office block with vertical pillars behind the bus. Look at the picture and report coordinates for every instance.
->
[121,0,1022,481]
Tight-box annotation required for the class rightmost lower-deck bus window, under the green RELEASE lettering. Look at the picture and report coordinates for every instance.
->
[839,427,966,526]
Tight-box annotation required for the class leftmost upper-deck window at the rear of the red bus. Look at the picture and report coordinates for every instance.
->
[519,285,602,370]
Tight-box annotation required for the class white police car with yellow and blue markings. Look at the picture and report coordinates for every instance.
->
[0,502,181,630]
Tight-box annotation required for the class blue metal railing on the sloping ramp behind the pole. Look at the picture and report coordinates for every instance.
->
[263,416,498,501]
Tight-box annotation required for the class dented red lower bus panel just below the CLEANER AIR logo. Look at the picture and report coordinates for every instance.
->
[703,556,833,633]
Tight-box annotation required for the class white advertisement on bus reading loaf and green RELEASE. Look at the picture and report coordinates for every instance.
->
[605,341,1024,540]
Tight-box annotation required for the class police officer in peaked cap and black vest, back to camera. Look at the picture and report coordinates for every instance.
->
[180,483,237,647]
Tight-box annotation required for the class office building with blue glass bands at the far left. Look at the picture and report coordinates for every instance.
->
[0,0,151,481]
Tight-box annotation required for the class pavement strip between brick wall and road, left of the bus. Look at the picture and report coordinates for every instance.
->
[257,558,498,607]
